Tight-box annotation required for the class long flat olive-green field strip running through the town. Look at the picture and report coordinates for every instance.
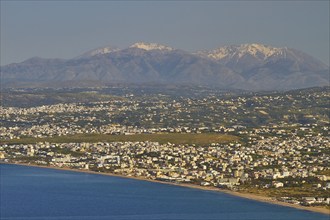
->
[1,133,239,145]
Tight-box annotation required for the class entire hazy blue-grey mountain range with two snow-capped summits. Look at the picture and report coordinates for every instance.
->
[1,43,329,90]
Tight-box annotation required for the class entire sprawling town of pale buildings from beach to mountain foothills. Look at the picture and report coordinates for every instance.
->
[0,85,330,208]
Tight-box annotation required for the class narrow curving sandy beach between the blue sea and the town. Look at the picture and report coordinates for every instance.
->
[0,162,330,216]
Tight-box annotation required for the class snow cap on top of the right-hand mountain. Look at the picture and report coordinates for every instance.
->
[197,43,286,60]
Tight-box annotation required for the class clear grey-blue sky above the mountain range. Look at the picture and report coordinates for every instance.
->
[0,0,330,65]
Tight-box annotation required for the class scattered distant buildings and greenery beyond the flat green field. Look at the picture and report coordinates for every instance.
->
[0,87,330,140]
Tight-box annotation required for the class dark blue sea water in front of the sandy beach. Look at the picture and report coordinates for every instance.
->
[0,164,329,220]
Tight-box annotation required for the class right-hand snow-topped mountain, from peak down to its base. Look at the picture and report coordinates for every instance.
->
[196,44,329,90]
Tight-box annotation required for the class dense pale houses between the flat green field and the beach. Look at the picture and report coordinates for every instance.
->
[0,129,330,204]
